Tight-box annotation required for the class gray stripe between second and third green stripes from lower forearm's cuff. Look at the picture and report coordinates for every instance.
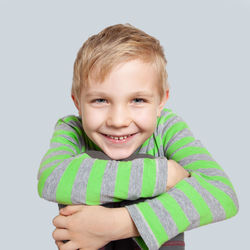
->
[168,188,200,229]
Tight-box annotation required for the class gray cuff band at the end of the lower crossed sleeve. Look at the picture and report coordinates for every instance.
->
[125,205,160,250]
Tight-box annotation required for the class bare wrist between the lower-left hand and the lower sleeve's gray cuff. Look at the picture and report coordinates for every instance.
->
[112,207,140,240]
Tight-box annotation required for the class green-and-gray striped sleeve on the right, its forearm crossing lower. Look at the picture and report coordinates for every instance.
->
[126,109,238,249]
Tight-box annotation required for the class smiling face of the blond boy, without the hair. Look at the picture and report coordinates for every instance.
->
[73,60,168,160]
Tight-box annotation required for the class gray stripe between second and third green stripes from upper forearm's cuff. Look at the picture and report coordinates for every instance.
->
[100,161,118,204]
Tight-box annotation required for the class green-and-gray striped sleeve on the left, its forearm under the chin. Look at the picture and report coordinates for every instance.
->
[38,116,167,205]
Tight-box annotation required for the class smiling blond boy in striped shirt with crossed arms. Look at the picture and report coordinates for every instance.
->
[38,25,238,249]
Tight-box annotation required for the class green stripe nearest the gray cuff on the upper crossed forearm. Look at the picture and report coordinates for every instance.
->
[140,158,156,197]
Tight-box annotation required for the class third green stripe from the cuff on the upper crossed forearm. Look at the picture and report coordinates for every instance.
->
[86,160,108,205]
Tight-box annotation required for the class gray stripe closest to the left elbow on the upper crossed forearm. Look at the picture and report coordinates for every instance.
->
[42,159,72,202]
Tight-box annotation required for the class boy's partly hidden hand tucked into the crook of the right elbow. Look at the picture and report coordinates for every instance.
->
[166,160,190,191]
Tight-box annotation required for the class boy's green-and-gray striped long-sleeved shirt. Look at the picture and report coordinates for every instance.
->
[38,109,238,249]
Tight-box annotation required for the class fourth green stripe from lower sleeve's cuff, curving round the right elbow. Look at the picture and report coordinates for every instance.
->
[193,173,237,219]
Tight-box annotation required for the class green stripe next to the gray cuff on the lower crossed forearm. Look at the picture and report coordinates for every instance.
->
[136,202,168,246]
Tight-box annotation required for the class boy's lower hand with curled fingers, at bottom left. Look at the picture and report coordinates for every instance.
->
[53,205,115,250]
